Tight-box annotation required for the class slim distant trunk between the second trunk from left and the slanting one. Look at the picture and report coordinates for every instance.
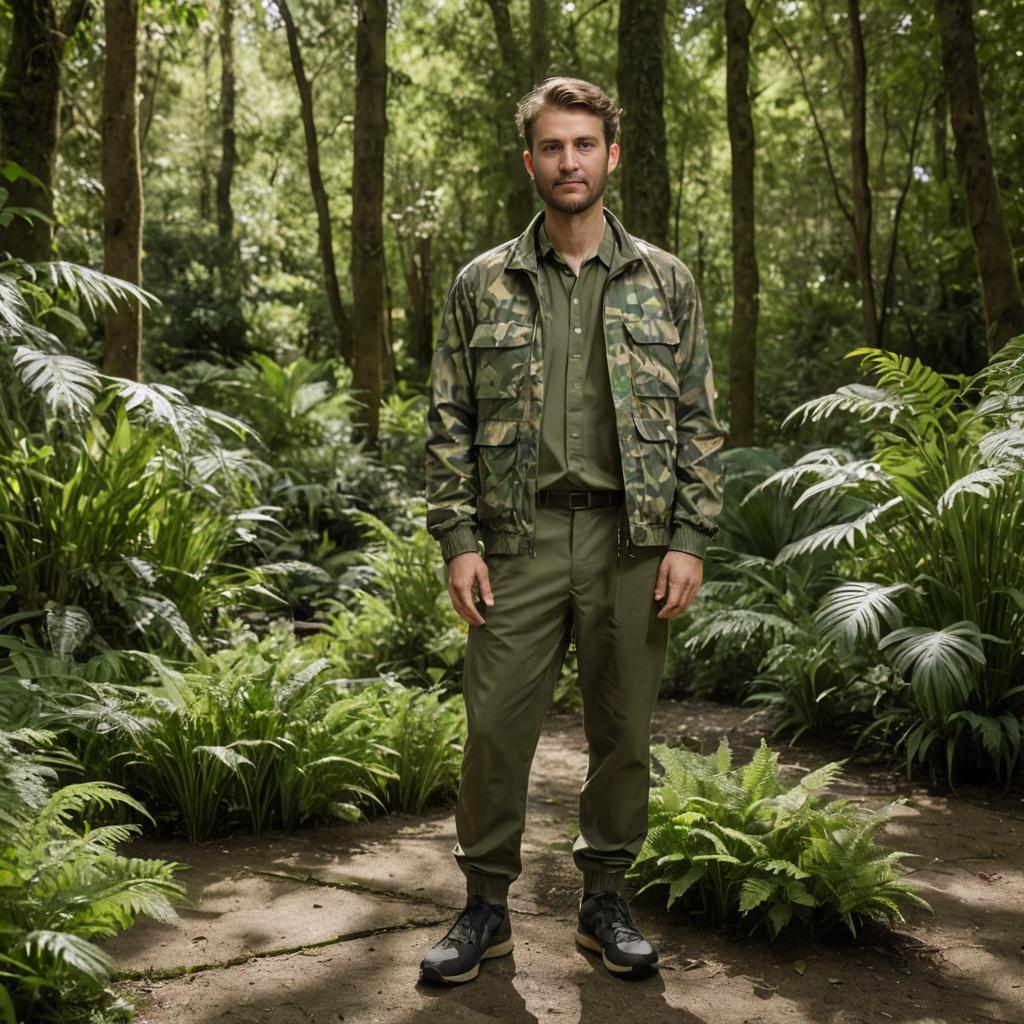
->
[211,0,246,356]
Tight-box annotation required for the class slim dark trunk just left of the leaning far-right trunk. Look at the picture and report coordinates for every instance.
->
[847,0,879,345]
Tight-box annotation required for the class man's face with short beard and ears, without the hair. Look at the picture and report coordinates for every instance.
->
[522,106,618,214]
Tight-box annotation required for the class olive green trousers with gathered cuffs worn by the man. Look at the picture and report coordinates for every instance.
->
[454,505,669,900]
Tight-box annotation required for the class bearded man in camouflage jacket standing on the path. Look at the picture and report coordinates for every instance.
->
[421,78,724,982]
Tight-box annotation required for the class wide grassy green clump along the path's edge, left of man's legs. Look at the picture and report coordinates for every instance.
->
[57,630,465,841]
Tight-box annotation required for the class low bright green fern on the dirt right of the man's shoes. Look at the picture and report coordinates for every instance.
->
[629,737,928,939]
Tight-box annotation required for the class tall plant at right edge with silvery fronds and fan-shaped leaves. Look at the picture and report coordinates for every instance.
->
[757,337,1024,785]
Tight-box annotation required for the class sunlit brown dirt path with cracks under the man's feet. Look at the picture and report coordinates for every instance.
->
[106,699,1024,1024]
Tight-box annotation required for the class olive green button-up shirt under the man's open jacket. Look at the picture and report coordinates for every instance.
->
[537,220,625,490]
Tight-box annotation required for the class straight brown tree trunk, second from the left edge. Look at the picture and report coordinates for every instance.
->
[101,0,142,380]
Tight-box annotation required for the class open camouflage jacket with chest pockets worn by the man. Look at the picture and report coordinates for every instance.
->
[426,210,725,561]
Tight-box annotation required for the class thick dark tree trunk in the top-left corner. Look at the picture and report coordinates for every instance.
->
[0,0,88,260]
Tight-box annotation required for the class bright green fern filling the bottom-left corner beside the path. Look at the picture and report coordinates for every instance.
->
[0,729,184,1024]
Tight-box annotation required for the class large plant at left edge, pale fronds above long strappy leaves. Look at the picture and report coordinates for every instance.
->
[0,253,292,646]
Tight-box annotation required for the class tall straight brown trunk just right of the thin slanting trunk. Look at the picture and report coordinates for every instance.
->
[352,0,387,444]
